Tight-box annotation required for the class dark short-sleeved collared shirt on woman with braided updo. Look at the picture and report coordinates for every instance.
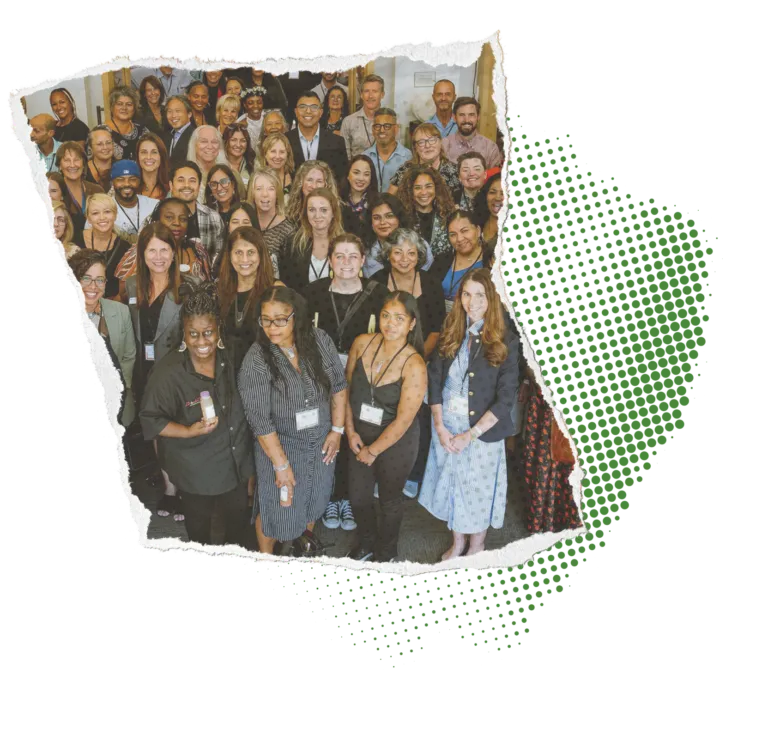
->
[140,339,254,496]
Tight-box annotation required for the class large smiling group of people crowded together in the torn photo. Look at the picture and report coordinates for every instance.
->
[37,70,523,561]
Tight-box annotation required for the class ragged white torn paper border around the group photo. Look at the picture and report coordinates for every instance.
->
[8,30,586,577]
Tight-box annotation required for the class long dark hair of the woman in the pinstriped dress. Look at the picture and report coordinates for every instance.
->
[256,286,331,397]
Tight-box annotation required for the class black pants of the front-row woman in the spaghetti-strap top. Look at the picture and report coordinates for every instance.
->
[348,419,419,560]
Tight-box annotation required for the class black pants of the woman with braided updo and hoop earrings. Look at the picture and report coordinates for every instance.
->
[181,481,248,545]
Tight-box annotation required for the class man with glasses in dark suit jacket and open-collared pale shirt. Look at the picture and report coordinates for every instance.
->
[287,91,347,183]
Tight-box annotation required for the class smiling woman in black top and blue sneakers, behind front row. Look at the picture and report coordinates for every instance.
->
[304,233,387,531]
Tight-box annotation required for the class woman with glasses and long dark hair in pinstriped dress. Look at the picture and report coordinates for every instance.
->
[238,287,347,554]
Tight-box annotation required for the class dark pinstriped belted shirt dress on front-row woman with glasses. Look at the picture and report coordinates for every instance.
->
[237,329,347,541]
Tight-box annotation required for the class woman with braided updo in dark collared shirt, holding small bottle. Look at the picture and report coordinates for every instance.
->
[140,283,254,545]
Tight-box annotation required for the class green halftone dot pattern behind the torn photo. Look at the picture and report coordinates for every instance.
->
[244,100,714,669]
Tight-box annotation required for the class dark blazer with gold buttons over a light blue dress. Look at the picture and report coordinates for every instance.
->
[427,329,520,442]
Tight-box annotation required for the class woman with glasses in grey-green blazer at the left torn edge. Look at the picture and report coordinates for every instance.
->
[69,250,136,426]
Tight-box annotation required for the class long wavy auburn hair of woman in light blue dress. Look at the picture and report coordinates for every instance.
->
[437,268,509,367]
